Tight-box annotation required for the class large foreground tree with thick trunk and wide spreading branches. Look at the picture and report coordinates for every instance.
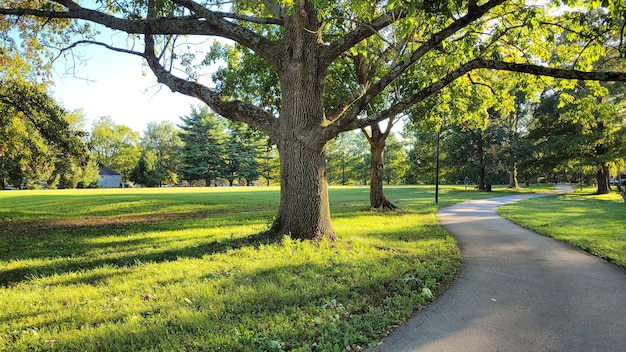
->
[0,0,626,239]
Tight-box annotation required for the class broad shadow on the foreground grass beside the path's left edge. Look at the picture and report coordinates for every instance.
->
[10,259,438,350]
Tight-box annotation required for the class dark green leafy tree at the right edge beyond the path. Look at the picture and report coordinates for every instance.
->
[526,83,626,194]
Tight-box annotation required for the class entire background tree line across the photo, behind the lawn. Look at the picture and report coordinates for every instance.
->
[0,46,626,193]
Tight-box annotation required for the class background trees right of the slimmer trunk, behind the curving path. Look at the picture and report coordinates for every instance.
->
[405,82,626,194]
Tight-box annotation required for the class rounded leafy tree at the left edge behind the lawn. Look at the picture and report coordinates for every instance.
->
[0,79,88,189]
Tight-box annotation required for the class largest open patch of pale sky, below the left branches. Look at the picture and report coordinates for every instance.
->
[53,38,200,132]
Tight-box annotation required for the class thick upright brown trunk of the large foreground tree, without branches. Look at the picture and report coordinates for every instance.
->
[270,2,335,240]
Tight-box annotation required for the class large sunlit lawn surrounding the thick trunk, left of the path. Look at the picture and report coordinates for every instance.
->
[0,186,536,351]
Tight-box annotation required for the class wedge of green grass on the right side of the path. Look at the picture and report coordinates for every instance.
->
[498,188,626,268]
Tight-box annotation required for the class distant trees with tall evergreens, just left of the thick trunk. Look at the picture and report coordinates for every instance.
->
[90,107,278,187]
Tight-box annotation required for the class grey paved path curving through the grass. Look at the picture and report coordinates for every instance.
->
[370,186,626,352]
